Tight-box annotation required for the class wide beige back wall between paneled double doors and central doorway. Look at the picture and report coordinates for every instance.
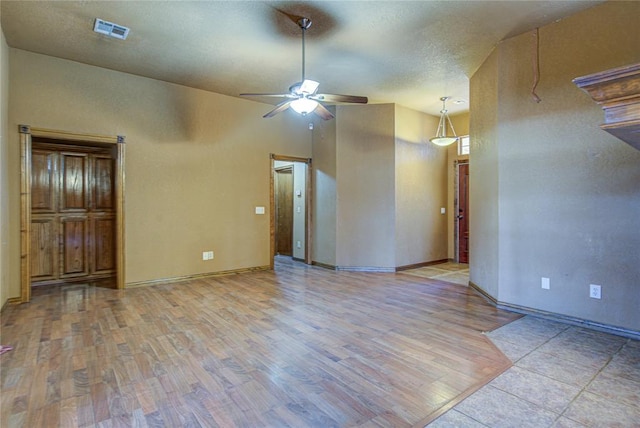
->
[8,49,311,297]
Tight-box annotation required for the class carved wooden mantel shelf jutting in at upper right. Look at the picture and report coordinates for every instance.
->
[573,64,640,150]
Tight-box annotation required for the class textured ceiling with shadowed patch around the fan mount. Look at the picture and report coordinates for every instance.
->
[0,0,602,115]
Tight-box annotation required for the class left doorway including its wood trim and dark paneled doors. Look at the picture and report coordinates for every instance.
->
[20,125,124,303]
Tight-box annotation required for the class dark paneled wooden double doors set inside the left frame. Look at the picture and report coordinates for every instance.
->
[31,142,116,285]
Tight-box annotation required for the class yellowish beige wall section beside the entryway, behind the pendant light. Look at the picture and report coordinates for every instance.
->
[395,105,447,267]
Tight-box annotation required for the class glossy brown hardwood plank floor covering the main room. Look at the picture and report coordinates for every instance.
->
[0,262,519,427]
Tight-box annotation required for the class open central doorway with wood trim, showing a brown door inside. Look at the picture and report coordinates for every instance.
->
[270,154,311,269]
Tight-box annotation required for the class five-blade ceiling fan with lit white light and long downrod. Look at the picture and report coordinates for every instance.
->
[240,18,369,120]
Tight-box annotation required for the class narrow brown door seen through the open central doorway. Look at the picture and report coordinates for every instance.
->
[275,167,293,256]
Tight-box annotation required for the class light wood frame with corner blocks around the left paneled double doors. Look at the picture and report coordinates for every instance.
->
[19,125,125,303]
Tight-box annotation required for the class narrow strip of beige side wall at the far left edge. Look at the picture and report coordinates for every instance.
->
[0,28,9,307]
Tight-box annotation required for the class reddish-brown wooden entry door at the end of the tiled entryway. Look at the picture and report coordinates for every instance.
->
[454,160,469,264]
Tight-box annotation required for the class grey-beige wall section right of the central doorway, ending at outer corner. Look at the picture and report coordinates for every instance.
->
[335,104,396,269]
